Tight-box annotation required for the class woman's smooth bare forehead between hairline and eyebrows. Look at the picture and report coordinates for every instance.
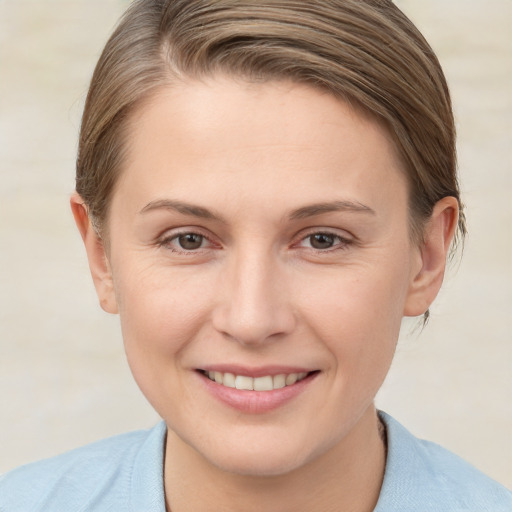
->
[118,77,403,218]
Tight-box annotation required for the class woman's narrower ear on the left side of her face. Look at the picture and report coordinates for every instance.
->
[70,192,118,313]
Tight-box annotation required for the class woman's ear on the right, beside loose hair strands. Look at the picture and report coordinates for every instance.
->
[404,197,459,316]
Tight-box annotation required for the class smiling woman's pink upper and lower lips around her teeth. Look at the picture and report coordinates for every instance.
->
[195,365,320,414]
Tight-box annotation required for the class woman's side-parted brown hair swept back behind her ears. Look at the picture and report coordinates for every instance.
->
[76,0,465,247]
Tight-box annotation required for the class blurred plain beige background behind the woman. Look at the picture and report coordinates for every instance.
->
[0,0,512,487]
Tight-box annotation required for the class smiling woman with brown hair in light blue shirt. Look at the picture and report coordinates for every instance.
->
[0,0,512,512]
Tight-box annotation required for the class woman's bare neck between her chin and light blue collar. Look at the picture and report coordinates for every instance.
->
[165,406,386,512]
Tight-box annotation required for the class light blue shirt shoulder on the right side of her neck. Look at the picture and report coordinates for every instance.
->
[375,413,512,512]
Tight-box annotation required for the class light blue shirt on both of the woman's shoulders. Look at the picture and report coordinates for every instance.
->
[0,413,512,512]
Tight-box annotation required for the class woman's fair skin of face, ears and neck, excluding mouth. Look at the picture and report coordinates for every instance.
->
[71,76,457,512]
